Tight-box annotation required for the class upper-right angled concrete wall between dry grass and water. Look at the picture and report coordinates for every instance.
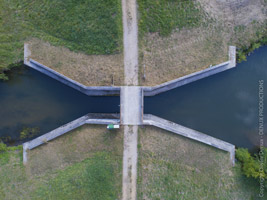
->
[143,46,236,96]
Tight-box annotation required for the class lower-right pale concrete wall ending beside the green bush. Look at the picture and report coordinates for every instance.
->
[143,114,235,165]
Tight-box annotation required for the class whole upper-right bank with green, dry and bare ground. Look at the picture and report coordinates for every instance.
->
[139,0,267,86]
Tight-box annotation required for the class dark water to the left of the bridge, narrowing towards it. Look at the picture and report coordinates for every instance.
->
[0,66,120,144]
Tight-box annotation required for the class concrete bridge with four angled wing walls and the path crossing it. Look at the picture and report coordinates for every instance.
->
[23,0,236,200]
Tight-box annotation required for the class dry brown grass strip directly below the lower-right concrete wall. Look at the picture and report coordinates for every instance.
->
[139,126,231,171]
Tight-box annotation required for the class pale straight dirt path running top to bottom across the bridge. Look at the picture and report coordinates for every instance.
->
[121,0,139,200]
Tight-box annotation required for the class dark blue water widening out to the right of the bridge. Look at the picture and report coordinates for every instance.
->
[144,46,267,149]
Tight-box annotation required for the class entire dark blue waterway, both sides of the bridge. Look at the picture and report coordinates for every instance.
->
[0,47,267,150]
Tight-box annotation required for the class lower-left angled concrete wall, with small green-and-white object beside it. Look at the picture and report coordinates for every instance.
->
[23,114,120,164]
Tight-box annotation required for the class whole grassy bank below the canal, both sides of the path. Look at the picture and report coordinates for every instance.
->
[0,125,259,200]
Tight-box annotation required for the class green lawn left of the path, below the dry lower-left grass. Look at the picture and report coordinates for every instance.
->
[0,148,121,200]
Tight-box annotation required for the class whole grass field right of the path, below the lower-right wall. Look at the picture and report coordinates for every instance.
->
[138,127,259,200]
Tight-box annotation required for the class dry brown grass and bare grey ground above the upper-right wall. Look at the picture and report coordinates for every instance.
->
[139,0,266,86]
